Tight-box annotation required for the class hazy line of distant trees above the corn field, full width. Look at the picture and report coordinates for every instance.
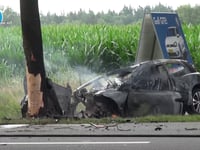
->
[0,3,200,26]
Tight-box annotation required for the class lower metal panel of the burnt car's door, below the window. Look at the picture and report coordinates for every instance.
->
[128,90,182,116]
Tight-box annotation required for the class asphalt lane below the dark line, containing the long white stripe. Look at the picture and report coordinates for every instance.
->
[0,137,200,150]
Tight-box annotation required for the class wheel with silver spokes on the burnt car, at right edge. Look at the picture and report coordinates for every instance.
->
[191,88,200,114]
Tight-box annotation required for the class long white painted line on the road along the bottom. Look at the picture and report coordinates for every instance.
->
[0,141,151,145]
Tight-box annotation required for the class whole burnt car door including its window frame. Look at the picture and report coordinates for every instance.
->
[126,64,182,116]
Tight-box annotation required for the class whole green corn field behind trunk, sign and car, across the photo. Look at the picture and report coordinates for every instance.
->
[0,24,200,82]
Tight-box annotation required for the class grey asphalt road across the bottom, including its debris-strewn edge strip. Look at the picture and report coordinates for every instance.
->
[0,122,200,150]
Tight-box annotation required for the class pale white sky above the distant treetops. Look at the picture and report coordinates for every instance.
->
[0,0,200,15]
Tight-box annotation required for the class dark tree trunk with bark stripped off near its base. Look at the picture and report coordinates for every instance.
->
[20,0,46,117]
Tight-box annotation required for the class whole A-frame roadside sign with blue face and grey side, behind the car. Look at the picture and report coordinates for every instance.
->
[135,12,193,64]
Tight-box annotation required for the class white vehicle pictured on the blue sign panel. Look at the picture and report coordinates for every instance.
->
[165,26,187,59]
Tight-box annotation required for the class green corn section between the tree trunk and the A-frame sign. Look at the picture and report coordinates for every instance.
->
[42,25,140,72]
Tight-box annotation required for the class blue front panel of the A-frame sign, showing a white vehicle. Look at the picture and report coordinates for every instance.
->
[151,13,193,64]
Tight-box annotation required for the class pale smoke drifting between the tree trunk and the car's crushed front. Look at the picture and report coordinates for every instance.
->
[44,51,97,89]
